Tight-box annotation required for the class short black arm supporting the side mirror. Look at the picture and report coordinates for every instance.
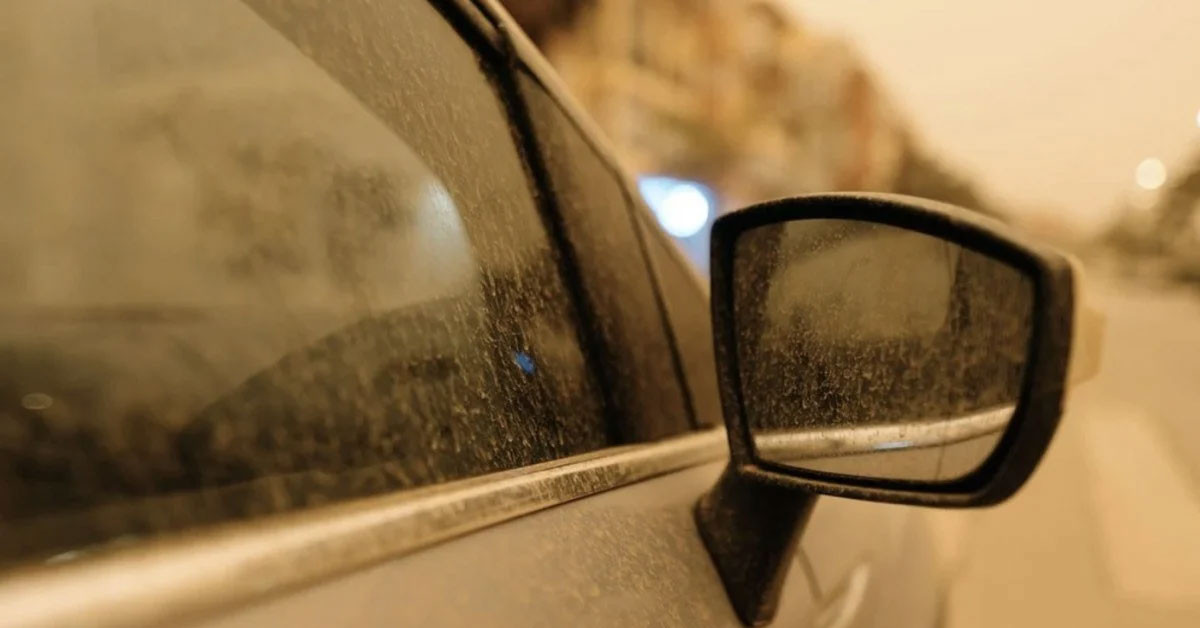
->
[695,461,817,626]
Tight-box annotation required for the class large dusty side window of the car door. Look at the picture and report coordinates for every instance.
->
[0,0,616,560]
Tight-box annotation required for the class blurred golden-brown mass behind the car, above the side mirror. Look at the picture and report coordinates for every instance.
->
[503,0,996,220]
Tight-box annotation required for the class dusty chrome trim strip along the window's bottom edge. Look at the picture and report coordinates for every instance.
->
[0,430,726,627]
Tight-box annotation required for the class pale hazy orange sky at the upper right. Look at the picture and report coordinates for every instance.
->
[791,0,1200,235]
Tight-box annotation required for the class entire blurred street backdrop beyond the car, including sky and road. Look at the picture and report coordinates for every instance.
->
[505,0,1200,627]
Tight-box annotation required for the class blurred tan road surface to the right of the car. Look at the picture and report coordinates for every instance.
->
[925,280,1200,628]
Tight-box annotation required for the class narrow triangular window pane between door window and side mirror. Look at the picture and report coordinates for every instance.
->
[518,73,694,441]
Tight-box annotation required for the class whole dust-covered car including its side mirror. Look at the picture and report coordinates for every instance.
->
[0,0,1076,628]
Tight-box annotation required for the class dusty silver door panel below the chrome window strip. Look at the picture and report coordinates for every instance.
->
[198,462,815,628]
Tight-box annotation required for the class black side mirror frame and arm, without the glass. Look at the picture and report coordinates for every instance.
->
[696,193,1074,626]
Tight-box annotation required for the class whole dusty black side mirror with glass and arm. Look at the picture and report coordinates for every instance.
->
[696,195,1074,624]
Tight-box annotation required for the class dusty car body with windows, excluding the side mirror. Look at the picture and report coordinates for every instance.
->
[0,0,942,627]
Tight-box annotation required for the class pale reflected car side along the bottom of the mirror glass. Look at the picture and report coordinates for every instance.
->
[754,405,1015,482]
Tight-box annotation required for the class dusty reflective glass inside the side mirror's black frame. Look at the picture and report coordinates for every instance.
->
[733,219,1034,483]
